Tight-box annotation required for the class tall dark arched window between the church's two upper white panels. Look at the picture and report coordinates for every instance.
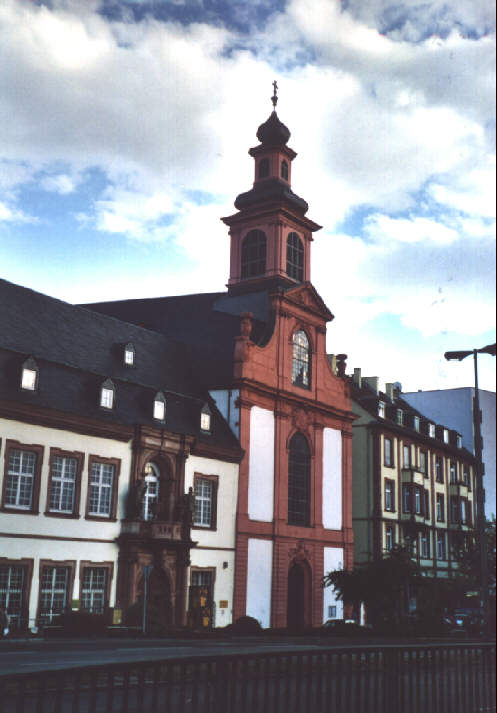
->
[288,433,311,527]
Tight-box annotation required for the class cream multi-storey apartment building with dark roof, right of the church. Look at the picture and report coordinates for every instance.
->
[351,369,476,596]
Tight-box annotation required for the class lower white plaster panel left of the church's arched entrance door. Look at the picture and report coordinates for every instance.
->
[246,538,273,627]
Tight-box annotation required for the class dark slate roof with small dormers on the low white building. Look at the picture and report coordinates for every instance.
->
[0,280,239,447]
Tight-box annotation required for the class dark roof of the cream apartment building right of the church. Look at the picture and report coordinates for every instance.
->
[350,378,474,460]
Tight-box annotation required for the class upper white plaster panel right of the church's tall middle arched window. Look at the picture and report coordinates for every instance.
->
[323,428,342,530]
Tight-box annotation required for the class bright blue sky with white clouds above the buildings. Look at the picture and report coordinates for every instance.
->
[0,0,495,390]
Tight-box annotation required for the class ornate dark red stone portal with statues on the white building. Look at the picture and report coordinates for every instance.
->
[117,428,196,630]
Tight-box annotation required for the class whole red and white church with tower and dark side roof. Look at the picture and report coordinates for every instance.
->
[89,101,353,628]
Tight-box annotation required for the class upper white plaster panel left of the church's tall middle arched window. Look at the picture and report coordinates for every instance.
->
[248,406,274,522]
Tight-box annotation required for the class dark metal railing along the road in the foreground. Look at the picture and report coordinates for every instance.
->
[0,643,496,713]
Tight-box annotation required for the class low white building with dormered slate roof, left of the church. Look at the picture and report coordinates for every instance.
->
[0,281,241,630]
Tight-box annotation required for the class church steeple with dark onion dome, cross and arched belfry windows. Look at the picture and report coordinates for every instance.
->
[222,82,321,291]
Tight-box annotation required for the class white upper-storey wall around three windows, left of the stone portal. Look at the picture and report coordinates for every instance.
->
[0,419,132,539]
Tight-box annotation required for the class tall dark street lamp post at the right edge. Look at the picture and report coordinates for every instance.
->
[444,344,496,630]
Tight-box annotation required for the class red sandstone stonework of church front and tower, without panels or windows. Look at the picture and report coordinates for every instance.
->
[223,103,353,627]
